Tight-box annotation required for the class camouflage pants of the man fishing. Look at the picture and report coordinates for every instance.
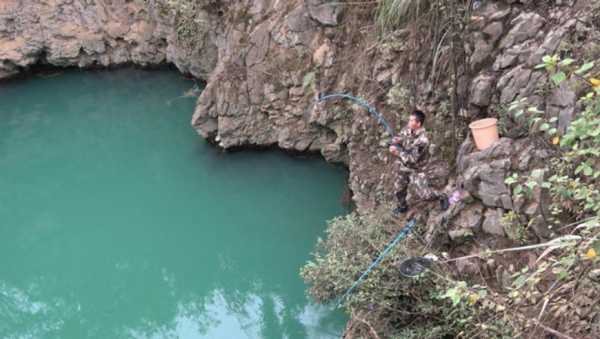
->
[394,171,441,206]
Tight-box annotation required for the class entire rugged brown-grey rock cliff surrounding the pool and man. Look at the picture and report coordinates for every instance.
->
[0,0,600,215]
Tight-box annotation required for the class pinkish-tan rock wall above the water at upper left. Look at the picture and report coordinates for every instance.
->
[0,0,217,78]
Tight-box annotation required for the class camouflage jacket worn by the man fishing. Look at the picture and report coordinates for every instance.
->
[397,127,429,172]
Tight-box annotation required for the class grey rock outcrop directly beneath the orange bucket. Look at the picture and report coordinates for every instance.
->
[440,134,551,243]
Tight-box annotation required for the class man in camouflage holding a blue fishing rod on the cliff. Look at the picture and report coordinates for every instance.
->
[390,110,448,215]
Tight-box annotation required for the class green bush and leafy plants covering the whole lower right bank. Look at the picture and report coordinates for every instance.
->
[302,56,600,338]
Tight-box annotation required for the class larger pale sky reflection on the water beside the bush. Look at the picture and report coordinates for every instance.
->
[124,290,338,339]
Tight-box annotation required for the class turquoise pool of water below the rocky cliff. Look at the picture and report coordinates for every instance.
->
[0,70,345,338]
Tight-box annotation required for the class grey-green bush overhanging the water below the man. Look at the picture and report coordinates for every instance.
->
[301,208,480,338]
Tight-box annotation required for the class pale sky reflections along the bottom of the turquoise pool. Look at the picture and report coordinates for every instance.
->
[0,278,339,339]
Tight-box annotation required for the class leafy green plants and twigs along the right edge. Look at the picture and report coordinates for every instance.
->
[480,56,600,338]
